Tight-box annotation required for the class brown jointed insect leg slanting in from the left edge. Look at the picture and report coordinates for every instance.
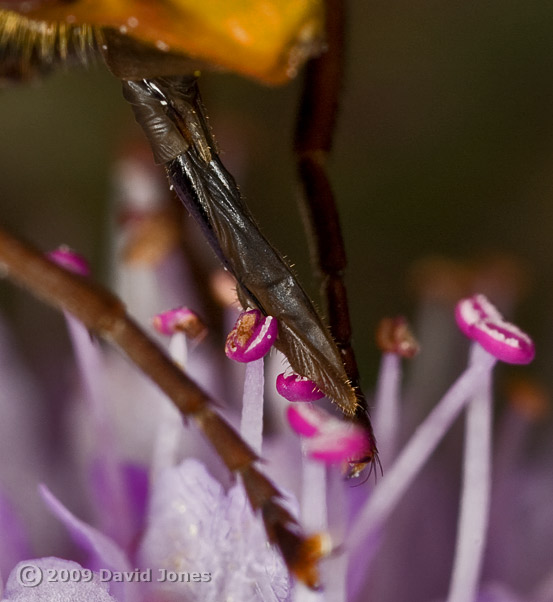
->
[0,228,320,587]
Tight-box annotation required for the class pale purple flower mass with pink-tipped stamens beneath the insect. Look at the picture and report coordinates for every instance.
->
[0,155,553,602]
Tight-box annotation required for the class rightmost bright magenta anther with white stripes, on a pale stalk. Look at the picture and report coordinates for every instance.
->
[455,295,536,364]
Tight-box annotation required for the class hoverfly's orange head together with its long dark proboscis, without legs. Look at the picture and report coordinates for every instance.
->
[0,0,376,580]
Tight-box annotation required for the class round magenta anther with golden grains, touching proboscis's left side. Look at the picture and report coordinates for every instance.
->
[225,309,278,363]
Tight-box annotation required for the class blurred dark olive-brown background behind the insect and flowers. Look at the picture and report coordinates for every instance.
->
[0,0,553,390]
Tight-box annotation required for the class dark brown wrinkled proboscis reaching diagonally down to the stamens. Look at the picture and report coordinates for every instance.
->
[124,78,357,415]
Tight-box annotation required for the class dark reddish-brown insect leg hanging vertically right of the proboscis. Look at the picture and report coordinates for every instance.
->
[294,0,372,436]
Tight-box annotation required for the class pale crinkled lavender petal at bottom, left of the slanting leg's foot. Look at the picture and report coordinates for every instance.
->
[139,459,289,602]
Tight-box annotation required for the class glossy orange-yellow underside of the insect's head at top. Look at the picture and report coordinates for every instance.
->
[0,0,323,84]
